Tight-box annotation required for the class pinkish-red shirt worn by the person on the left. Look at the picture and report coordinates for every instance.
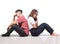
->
[17,16,29,34]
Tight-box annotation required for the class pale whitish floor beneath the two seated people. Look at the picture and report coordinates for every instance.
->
[0,35,60,44]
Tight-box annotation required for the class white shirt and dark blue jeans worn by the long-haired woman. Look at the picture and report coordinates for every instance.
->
[28,17,54,36]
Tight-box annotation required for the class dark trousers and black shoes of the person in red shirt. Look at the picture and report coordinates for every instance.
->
[3,24,28,36]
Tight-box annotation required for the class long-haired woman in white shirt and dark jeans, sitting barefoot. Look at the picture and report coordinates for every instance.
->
[28,9,57,36]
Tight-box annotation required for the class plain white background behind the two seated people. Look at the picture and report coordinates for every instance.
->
[0,0,60,34]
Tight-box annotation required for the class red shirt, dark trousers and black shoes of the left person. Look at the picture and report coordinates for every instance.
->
[2,16,29,36]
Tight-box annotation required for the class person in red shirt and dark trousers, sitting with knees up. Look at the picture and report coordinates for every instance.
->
[2,9,29,36]
